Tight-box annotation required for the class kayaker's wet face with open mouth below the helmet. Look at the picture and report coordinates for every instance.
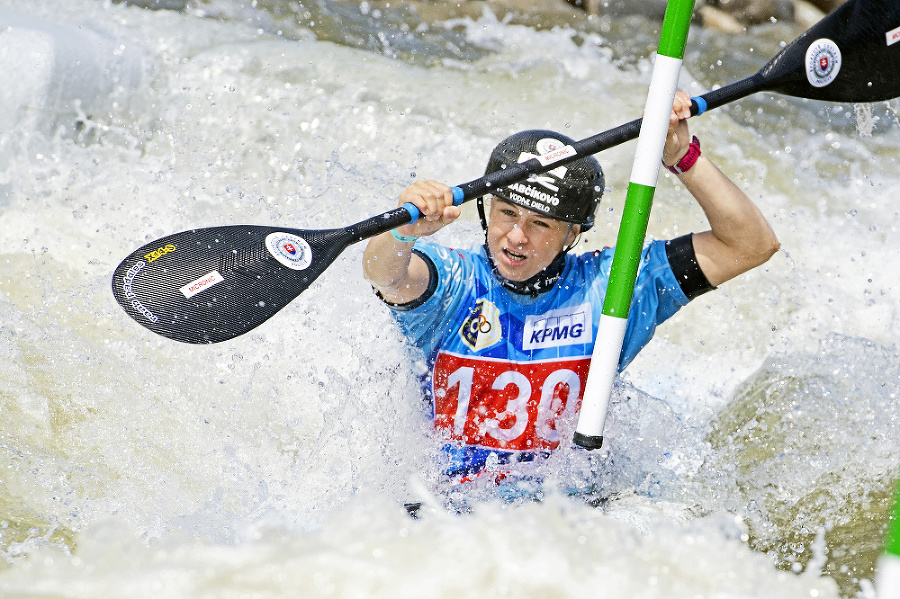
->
[487,198,580,281]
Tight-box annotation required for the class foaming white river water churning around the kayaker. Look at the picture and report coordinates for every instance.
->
[0,0,900,599]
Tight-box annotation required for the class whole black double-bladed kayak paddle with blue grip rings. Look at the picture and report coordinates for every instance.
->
[112,0,900,343]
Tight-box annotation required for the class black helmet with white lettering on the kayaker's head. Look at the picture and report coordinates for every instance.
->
[484,129,605,231]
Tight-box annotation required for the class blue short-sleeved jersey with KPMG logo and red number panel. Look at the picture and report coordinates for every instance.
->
[386,241,689,478]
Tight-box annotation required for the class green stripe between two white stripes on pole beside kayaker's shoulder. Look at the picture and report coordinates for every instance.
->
[603,183,656,318]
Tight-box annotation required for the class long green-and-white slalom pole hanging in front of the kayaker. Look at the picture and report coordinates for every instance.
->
[574,0,694,449]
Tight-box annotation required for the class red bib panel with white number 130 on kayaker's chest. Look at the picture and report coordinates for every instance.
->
[433,352,590,451]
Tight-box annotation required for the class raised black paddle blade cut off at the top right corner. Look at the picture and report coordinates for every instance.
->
[760,0,900,102]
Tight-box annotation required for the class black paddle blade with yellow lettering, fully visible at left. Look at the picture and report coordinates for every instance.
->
[112,225,356,343]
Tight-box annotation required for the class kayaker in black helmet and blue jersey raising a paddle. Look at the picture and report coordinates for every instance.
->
[364,92,779,496]
